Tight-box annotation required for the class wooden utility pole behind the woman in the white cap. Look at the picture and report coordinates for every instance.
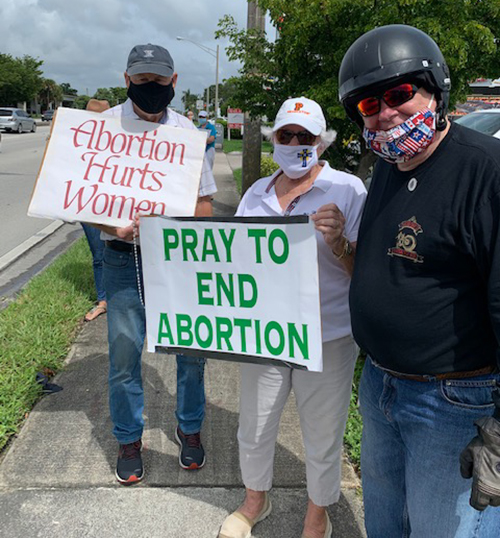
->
[242,2,265,194]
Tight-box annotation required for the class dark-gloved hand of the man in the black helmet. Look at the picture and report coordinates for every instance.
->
[460,417,500,510]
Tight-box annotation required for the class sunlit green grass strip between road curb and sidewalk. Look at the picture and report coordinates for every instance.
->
[0,238,95,450]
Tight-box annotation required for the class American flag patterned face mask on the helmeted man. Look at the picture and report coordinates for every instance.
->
[363,96,436,163]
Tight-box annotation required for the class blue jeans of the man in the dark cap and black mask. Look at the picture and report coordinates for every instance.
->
[103,247,205,444]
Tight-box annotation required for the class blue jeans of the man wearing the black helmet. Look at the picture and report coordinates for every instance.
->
[359,359,500,538]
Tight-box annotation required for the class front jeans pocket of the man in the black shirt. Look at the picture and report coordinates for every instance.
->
[441,378,496,409]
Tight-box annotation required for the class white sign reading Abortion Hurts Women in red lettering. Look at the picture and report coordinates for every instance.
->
[28,108,206,226]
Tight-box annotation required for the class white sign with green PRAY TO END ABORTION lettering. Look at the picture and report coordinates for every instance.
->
[141,217,323,372]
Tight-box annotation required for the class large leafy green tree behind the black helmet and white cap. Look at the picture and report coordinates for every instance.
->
[216,0,500,172]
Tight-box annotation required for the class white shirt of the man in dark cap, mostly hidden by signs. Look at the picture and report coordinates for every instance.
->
[101,99,217,242]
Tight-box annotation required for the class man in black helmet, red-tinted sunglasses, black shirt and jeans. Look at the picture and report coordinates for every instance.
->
[339,25,500,538]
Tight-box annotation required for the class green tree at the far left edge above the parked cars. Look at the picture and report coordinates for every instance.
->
[0,54,43,106]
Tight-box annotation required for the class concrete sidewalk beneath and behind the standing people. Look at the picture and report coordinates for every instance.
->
[0,153,365,538]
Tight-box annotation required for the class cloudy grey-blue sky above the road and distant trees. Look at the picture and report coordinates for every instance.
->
[0,0,270,108]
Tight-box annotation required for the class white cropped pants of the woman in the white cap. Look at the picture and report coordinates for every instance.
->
[238,336,356,506]
